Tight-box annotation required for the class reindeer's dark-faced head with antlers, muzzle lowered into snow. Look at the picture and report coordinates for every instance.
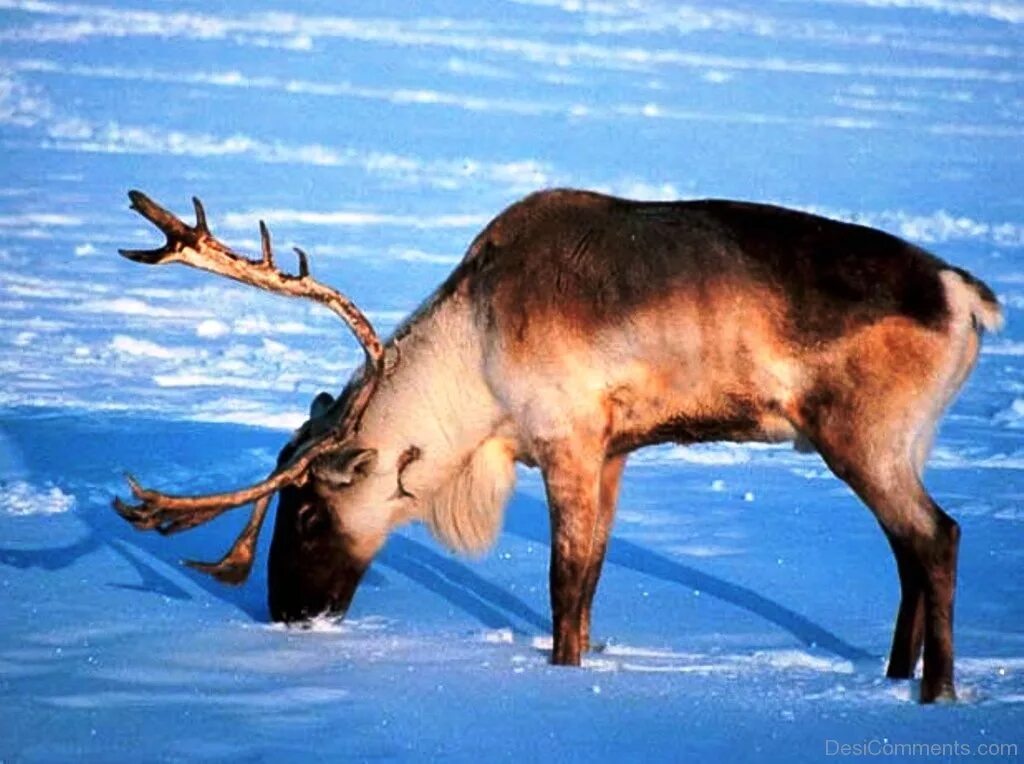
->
[114,190,393,622]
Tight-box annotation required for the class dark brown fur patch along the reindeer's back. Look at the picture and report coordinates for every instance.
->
[464,190,962,343]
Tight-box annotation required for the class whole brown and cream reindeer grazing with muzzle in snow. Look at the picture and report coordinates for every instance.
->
[115,189,1002,703]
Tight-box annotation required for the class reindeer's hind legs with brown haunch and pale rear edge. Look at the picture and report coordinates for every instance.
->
[791,311,978,703]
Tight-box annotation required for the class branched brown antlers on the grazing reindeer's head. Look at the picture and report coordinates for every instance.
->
[114,190,384,584]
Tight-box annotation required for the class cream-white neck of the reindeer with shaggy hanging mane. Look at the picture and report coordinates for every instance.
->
[360,288,515,553]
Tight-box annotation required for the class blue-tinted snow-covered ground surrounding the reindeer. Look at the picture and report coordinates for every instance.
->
[0,0,1024,762]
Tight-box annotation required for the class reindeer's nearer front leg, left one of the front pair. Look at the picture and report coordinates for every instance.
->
[541,438,603,666]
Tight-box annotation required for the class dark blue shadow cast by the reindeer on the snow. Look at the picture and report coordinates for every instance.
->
[0,410,873,661]
